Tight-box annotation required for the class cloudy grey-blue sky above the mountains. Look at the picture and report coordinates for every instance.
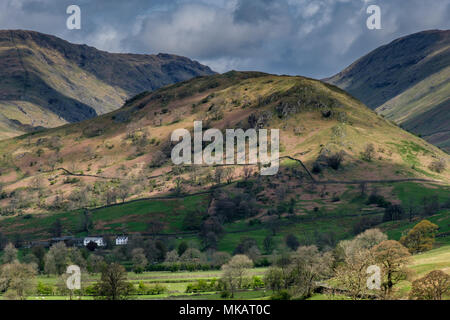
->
[0,0,450,79]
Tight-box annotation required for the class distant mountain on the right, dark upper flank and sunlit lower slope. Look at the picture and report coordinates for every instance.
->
[325,30,450,152]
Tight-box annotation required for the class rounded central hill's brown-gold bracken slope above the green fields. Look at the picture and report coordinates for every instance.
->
[0,72,450,220]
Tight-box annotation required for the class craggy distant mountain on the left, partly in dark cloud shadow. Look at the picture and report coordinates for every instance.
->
[0,30,214,139]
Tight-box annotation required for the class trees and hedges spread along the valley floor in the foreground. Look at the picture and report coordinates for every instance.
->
[0,215,449,300]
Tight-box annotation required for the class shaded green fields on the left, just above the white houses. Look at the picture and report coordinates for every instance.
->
[0,195,208,239]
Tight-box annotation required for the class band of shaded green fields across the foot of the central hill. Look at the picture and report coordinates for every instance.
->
[0,182,450,253]
